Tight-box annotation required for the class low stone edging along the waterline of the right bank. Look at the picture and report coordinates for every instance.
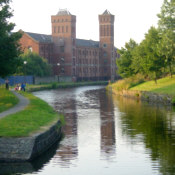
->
[111,87,173,105]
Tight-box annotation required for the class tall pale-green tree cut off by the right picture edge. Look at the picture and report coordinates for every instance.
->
[158,0,175,77]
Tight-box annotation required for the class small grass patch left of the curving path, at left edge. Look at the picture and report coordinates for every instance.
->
[0,87,19,112]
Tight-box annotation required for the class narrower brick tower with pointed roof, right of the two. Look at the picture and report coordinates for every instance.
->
[99,10,116,81]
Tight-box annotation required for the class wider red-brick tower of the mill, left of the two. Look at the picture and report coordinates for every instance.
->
[51,9,76,81]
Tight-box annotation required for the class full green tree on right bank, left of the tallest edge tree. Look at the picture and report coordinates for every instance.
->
[133,27,164,83]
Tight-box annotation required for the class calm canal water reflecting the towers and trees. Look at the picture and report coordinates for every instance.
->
[0,86,175,175]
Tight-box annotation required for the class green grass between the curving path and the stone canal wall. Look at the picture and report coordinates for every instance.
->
[0,92,64,137]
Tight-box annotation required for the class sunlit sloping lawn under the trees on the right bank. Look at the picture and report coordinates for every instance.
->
[129,76,175,96]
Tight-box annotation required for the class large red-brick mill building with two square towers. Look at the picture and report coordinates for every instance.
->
[20,10,119,81]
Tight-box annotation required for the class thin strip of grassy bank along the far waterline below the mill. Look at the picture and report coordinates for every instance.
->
[27,81,108,92]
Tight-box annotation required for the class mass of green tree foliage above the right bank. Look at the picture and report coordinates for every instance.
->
[117,0,175,83]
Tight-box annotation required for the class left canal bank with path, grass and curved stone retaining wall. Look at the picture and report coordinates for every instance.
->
[0,92,63,162]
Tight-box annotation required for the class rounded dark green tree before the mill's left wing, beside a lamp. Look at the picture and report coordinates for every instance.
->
[18,51,52,77]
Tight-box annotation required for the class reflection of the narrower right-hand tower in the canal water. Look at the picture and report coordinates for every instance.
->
[99,90,115,157]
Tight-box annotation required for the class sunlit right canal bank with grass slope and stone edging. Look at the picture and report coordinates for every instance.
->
[107,76,175,105]
